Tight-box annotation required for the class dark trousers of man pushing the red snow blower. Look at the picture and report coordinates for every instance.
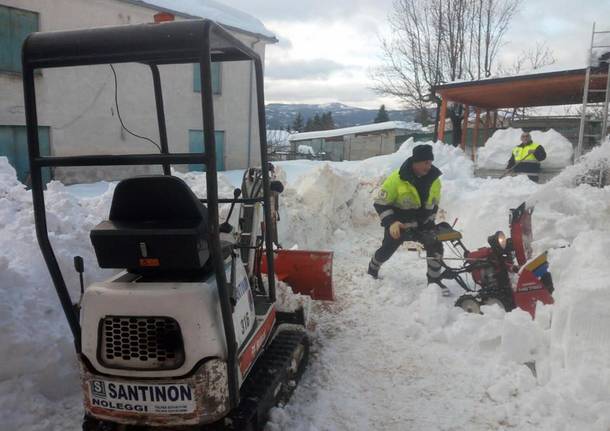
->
[369,228,443,282]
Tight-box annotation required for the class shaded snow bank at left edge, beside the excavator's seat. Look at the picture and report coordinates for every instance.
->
[0,162,116,429]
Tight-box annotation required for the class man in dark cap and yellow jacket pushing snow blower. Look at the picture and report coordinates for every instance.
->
[368,145,450,296]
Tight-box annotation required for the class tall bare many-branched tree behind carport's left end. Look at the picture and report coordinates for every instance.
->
[372,0,521,143]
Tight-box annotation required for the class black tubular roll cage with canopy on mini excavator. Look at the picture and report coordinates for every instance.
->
[22,20,275,407]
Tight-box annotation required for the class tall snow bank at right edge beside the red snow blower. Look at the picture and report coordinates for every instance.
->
[400,143,610,430]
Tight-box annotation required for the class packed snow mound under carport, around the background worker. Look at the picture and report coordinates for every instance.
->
[477,128,574,169]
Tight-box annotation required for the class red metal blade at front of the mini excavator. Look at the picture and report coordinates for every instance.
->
[261,250,334,301]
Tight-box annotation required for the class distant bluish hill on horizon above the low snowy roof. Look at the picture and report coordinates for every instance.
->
[265,103,426,129]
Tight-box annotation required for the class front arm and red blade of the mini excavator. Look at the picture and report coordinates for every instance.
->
[239,163,334,301]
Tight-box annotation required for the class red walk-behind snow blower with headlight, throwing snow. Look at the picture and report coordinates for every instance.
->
[418,203,553,317]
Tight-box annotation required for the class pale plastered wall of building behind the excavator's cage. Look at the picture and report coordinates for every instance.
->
[0,0,265,183]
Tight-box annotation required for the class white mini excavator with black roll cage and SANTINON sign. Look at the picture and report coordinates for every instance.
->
[22,20,318,431]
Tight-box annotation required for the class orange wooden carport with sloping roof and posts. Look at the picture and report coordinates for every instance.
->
[433,67,608,159]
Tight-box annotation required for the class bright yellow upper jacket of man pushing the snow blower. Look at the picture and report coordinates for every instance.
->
[377,169,441,210]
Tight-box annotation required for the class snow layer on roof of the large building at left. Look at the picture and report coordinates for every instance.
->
[121,0,277,42]
